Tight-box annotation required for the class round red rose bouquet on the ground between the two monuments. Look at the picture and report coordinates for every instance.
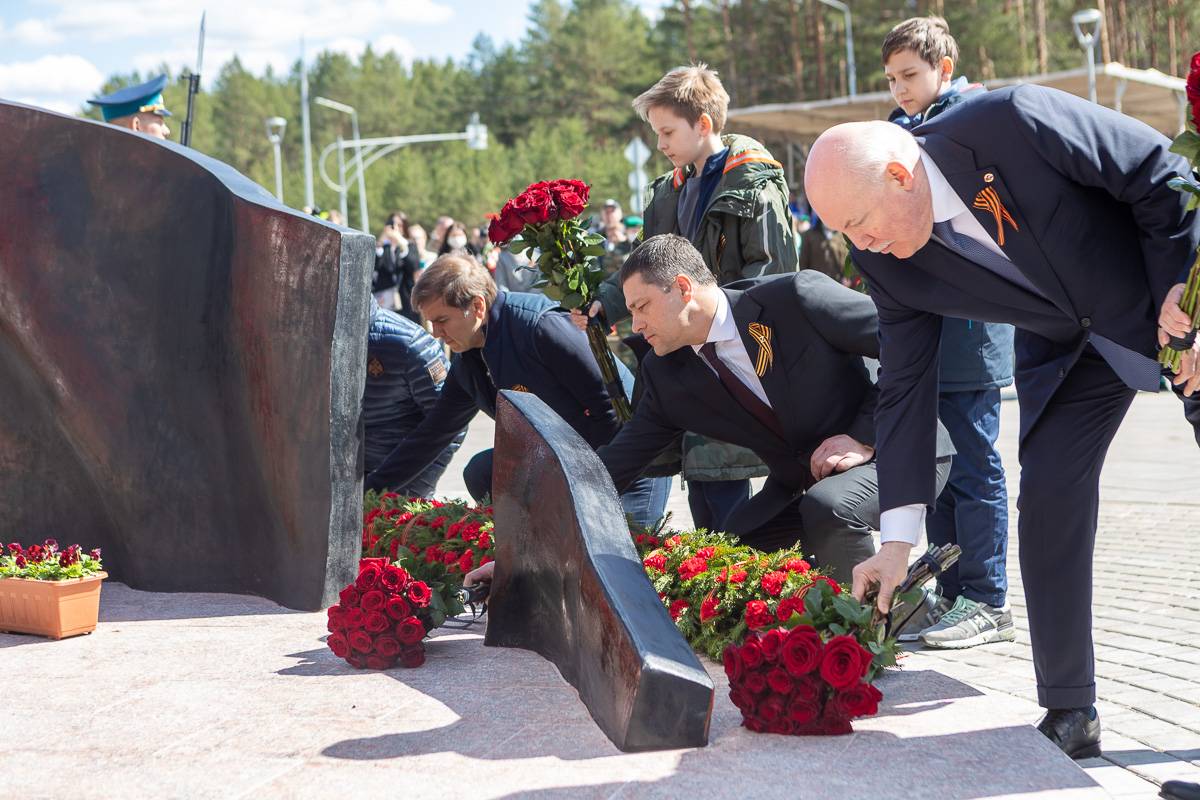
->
[326,559,436,669]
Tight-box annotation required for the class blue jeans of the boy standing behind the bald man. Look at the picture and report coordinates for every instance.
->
[925,389,1008,607]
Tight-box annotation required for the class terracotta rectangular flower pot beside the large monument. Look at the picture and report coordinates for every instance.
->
[0,572,108,639]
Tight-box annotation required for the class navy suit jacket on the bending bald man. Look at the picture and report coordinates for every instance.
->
[851,85,1200,510]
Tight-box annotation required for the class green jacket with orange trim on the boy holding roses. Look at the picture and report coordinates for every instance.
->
[600,134,799,481]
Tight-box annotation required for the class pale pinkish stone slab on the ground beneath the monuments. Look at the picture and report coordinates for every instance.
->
[0,583,1099,800]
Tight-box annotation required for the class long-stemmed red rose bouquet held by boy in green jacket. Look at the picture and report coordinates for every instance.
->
[487,179,632,422]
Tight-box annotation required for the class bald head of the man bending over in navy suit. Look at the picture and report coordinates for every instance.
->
[804,121,934,258]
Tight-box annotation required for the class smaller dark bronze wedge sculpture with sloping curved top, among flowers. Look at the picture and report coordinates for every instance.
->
[484,391,713,751]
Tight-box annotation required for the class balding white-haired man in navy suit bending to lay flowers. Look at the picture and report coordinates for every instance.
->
[805,85,1200,758]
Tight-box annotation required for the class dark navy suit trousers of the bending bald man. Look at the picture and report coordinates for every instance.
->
[1016,347,1135,709]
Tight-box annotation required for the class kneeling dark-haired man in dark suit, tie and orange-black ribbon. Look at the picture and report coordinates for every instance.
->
[596,234,954,581]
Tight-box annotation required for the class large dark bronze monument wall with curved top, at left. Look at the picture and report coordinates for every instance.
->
[0,102,373,609]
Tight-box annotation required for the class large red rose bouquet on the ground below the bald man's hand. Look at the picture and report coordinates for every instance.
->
[722,581,895,735]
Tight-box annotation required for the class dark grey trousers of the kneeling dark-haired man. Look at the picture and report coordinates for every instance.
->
[727,456,950,583]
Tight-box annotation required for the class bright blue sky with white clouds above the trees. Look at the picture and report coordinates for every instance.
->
[0,0,665,113]
